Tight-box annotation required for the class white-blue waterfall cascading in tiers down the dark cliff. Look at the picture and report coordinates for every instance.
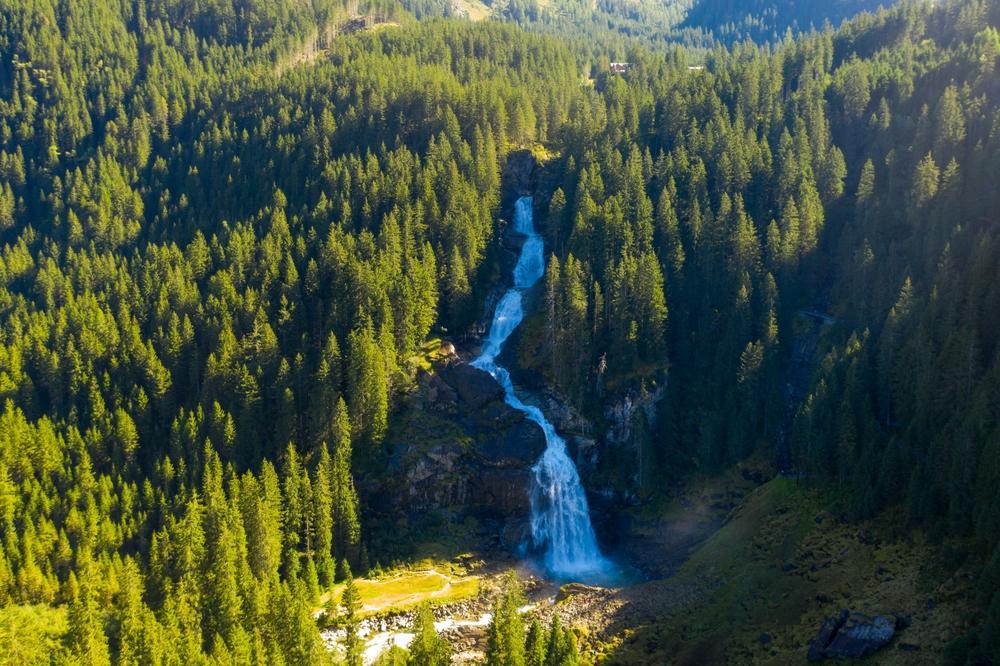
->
[472,197,611,580]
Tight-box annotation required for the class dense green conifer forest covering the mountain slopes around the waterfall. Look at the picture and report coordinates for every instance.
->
[0,0,1000,666]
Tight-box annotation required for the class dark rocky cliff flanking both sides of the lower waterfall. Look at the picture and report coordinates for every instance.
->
[372,344,665,551]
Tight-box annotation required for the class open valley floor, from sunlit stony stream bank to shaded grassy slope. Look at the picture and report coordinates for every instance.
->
[342,467,974,664]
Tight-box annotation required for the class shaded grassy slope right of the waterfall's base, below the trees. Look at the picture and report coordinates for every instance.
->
[608,478,971,665]
